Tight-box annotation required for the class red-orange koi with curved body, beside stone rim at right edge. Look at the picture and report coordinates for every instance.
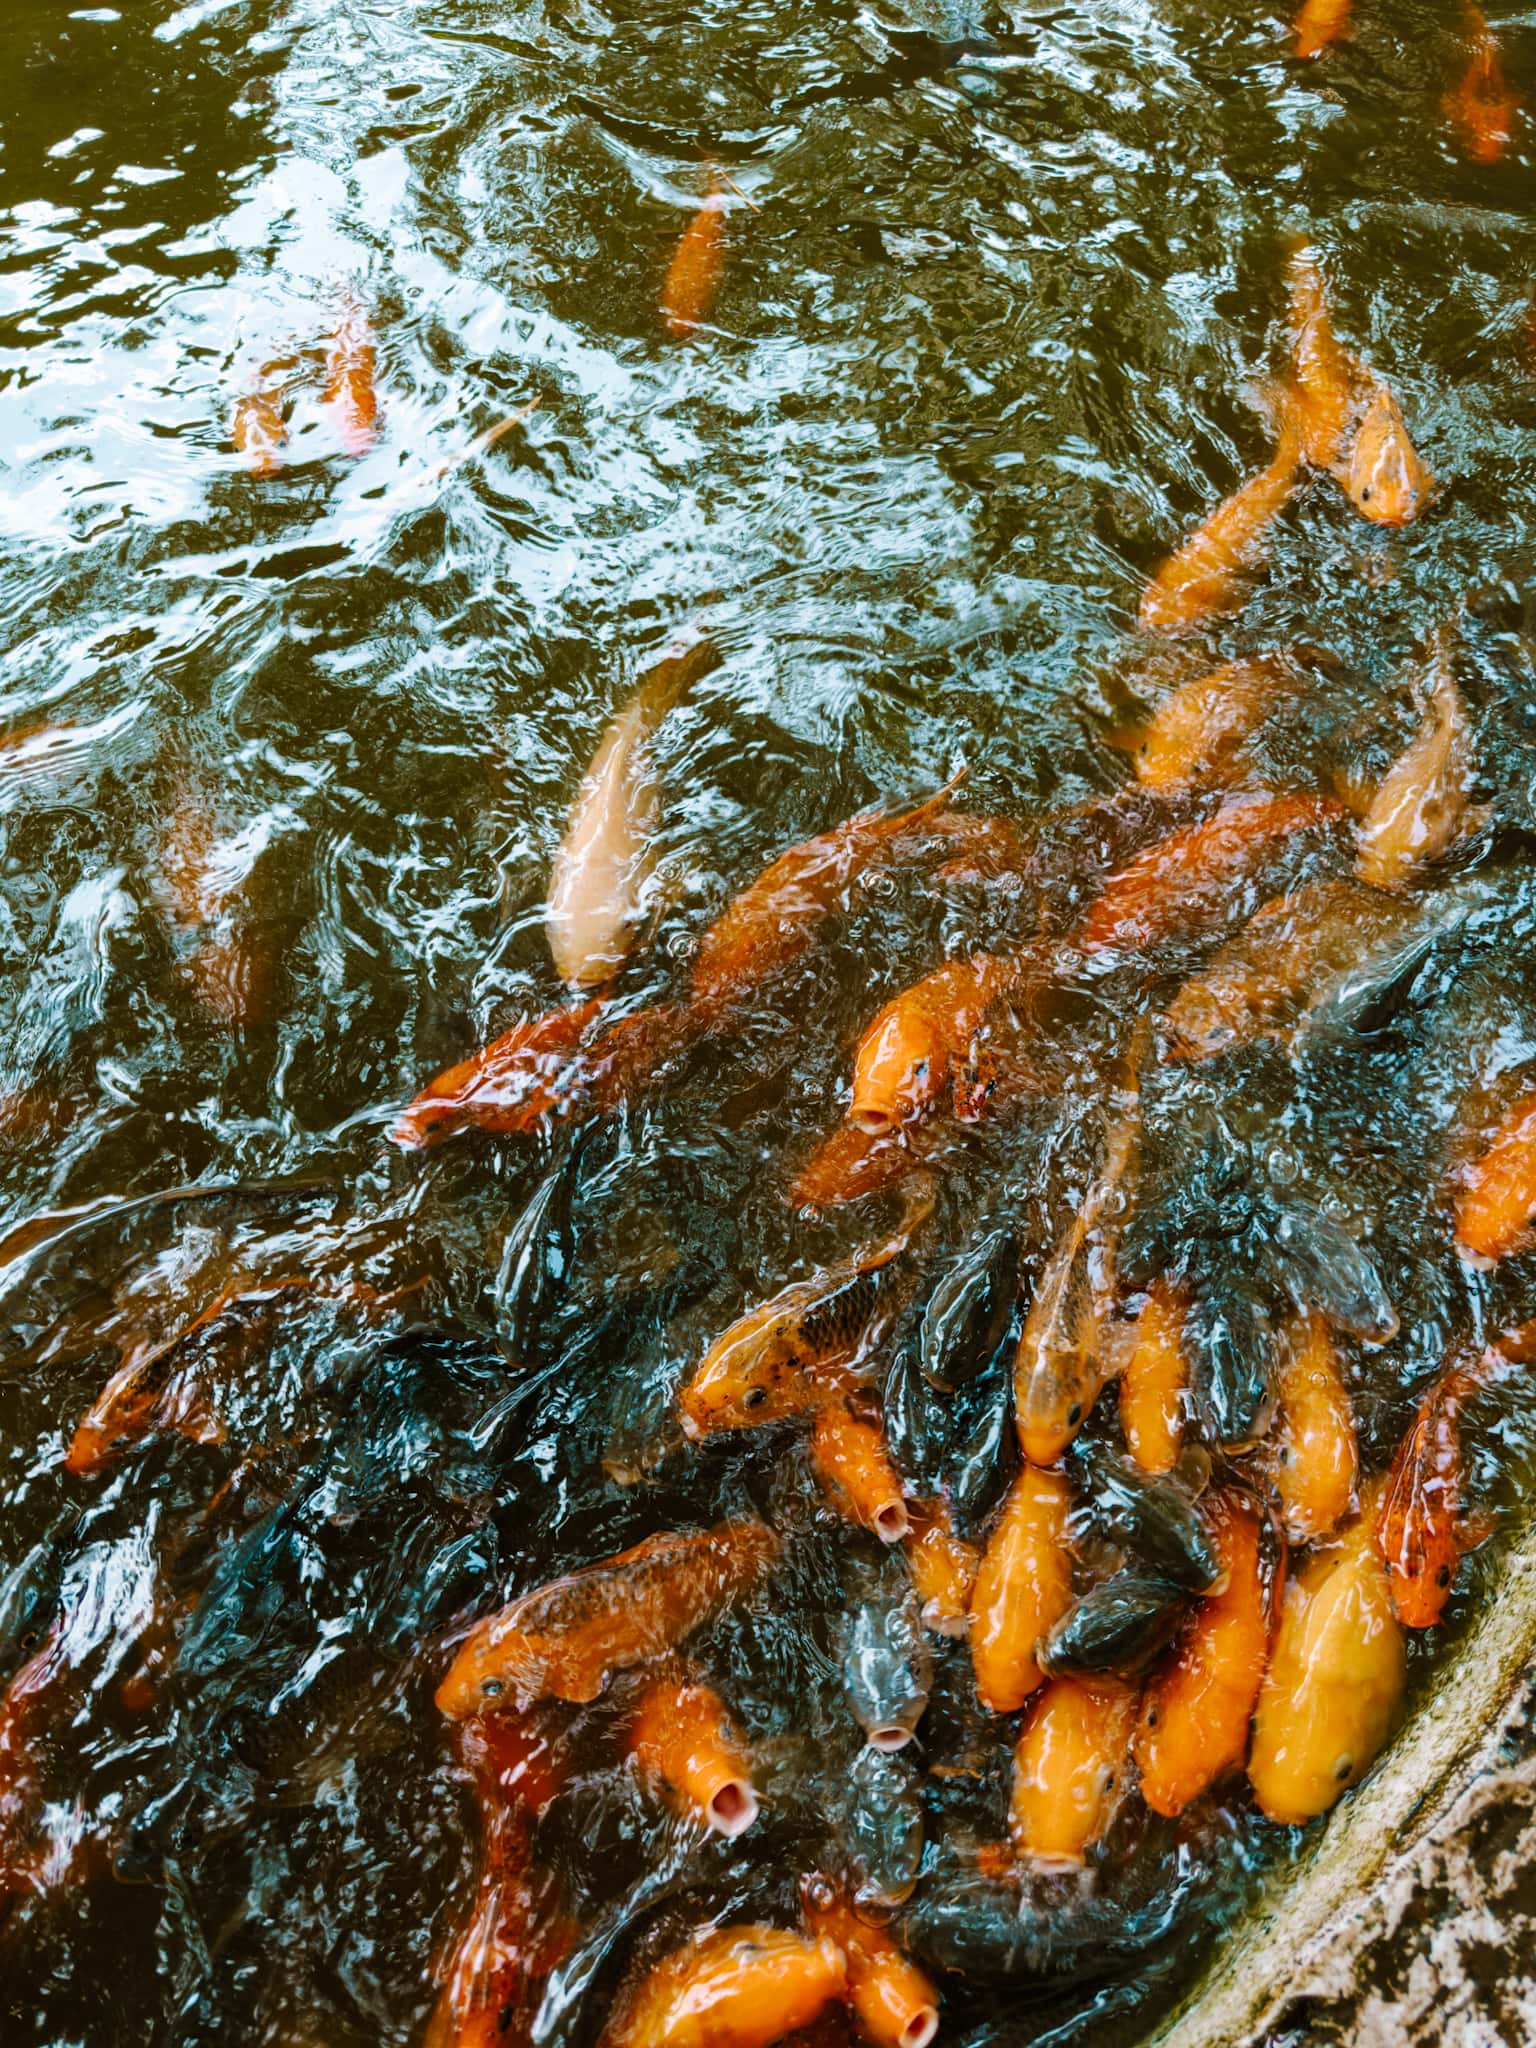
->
[1376,1323,1536,1628]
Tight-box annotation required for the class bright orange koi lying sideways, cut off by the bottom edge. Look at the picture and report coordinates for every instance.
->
[604,1927,848,2048]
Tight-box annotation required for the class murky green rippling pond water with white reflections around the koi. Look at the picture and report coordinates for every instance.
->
[0,0,1536,2048]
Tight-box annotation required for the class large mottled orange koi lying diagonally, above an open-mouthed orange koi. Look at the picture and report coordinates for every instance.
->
[436,1522,778,1720]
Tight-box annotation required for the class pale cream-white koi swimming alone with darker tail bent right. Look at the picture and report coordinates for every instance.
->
[545,639,721,989]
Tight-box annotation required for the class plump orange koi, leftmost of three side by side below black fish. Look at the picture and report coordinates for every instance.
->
[1008,1677,1137,1868]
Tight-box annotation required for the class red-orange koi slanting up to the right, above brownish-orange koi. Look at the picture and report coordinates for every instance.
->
[1077,797,1346,952]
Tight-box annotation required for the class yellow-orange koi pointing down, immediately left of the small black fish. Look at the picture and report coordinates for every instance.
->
[971,1464,1071,1714]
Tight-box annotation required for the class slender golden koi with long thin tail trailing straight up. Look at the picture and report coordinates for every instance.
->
[1014,1032,1141,1464]
